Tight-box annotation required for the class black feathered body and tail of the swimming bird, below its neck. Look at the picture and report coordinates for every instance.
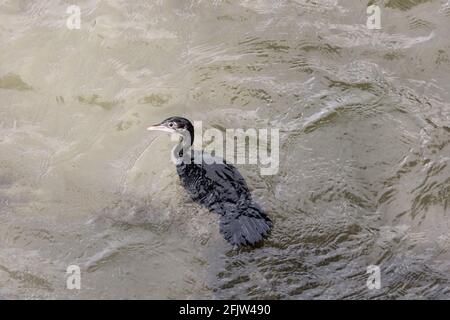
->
[177,151,272,246]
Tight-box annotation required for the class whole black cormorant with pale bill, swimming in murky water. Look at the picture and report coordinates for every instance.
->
[147,117,272,246]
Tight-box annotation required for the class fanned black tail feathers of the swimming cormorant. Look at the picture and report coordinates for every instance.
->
[220,203,273,246]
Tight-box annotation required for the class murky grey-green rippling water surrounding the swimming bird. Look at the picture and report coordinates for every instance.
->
[0,0,450,299]
